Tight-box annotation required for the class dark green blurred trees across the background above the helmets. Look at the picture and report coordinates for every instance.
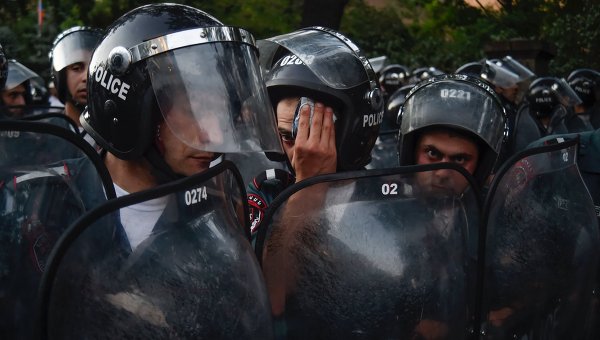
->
[0,0,600,83]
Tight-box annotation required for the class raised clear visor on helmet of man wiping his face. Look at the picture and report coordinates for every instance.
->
[258,30,370,89]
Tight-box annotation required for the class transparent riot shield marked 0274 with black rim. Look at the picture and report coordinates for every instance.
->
[41,161,273,339]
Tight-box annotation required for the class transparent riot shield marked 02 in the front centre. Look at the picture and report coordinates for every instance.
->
[256,163,479,339]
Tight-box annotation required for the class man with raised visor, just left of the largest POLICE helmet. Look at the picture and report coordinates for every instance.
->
[49,26,102,139]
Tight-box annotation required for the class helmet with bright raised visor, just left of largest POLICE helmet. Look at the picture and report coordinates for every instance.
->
[48,26,102,105]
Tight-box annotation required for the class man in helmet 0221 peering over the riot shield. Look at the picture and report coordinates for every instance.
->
[398,74,506,193]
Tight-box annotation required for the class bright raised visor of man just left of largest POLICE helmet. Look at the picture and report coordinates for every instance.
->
[52,31,100,71]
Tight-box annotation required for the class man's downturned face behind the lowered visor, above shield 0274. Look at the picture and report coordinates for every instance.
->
[157,100,220,176]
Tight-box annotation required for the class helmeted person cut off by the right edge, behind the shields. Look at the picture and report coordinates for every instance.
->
[567,69,600,132]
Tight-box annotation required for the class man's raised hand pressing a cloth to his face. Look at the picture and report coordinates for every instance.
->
[291,103,337,182]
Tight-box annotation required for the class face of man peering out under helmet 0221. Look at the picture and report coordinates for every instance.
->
[415,130,479,194]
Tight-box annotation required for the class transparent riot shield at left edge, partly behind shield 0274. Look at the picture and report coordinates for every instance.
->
[0,120,115,339]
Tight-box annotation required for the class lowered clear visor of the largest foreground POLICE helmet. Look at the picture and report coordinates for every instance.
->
[148,42,283,153]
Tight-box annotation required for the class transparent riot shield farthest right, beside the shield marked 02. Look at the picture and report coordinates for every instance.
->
[480,141,600,339]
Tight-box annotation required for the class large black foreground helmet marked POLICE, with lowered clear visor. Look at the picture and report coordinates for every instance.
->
[80,4,283,161]
